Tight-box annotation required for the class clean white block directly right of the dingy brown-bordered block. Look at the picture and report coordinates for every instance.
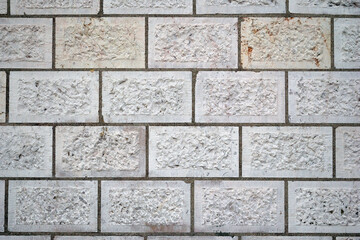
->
[149,127,239,177]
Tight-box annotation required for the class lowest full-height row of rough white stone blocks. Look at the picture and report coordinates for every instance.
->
[0,180,360,233]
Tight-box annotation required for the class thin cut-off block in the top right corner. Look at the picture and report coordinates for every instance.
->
[289,0,360,15]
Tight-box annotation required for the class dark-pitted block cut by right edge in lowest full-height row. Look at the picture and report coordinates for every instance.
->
[288,182,360,233]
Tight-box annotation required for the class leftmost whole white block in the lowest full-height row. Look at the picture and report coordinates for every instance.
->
[9,181,97,232]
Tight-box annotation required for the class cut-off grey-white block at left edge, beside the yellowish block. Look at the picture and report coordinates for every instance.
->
[0,18,52,68]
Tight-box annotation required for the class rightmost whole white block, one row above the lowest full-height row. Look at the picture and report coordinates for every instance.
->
[242,127,332,178]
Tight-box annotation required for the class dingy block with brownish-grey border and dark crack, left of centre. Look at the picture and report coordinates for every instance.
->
[56,127,145,177]
